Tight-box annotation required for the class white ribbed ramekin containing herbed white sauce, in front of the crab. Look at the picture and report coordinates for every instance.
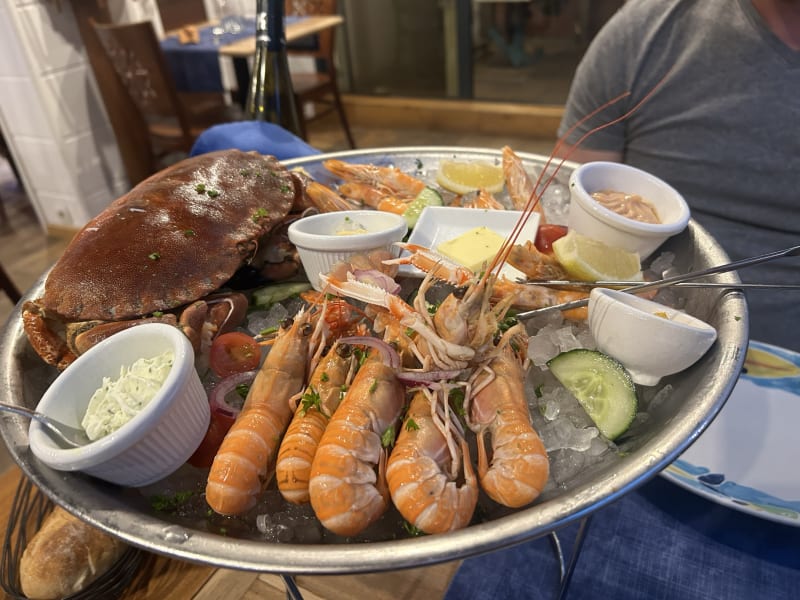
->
[28,323,210,487]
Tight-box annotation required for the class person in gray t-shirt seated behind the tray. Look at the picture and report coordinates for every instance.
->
[559,0,800,351]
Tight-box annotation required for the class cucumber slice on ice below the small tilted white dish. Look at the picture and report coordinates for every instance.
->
[547,348,636,440]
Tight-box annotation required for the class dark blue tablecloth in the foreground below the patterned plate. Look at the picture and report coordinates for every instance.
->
[446,476,800,600]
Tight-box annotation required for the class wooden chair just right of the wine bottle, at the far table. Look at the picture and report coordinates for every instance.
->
[286,0,356,148]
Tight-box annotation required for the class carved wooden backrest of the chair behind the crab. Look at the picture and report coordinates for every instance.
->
[92,21,192,151]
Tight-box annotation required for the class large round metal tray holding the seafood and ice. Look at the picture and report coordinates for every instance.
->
[0,147,748,574]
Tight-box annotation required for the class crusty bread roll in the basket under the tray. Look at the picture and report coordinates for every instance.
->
[20,506,127,600]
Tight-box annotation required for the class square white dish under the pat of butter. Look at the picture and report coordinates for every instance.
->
[400,206,539,280]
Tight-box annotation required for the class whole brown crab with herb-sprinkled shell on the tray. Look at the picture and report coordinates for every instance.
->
[22,150,304,369]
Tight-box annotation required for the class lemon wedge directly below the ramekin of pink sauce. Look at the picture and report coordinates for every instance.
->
[553,231,642,281]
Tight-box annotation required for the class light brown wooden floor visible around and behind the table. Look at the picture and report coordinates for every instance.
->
[0,121,552,600]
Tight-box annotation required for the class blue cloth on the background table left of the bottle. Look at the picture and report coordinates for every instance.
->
[161,16,316,92]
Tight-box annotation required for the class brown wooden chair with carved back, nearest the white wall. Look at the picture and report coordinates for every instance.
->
[90,19,235,185]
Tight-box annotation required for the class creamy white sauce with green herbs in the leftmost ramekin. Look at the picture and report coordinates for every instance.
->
[81,350,175,441]
